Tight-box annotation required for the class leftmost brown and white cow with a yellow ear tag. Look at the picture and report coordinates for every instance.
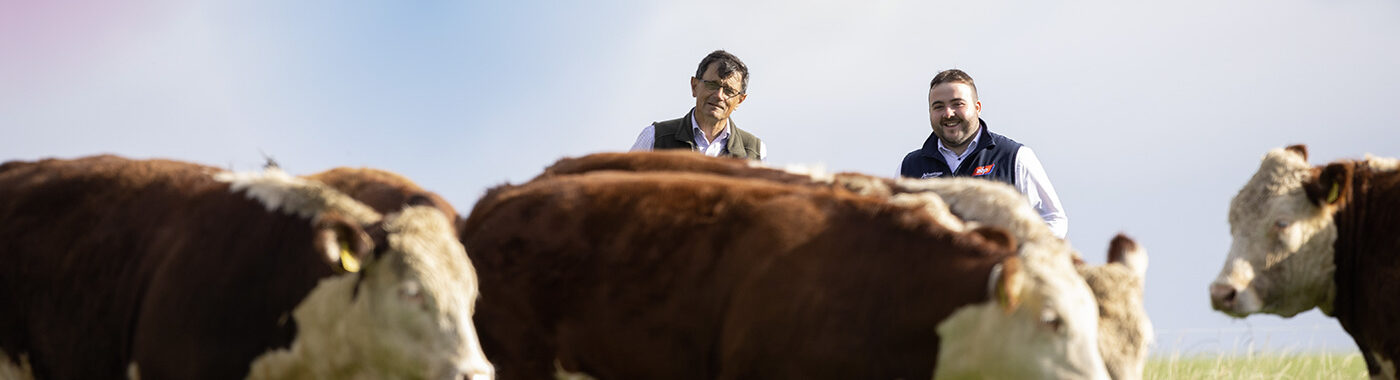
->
[0,156,493,380]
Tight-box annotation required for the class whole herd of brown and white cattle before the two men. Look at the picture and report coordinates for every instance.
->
[0,146,1400,380]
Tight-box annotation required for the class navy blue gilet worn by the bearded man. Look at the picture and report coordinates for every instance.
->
[899,118,1021,185]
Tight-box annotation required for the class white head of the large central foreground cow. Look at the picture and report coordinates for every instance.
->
[934,255,1109,379]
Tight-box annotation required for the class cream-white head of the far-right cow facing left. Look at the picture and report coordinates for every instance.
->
[1210,146,1351,317]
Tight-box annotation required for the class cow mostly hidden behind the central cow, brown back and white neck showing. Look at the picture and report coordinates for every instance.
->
[536,150,1154,380]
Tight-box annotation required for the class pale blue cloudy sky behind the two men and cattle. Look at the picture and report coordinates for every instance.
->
[0,0,1400,355]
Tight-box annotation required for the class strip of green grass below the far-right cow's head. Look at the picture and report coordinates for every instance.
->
[1142,353,1368,380]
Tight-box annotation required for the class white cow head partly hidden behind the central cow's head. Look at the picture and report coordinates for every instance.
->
[1079,234,1152,380]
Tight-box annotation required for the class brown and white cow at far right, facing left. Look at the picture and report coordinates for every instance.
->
[1210,146,1400,379]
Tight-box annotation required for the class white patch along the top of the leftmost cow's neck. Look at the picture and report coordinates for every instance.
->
[214,168,379,224]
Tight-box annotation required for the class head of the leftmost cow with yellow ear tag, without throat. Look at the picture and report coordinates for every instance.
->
[336,206,491,380]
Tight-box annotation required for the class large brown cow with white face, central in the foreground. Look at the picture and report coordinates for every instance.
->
[462,171,1107,379]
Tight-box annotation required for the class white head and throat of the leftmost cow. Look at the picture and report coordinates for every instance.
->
[251,206,490,379]
